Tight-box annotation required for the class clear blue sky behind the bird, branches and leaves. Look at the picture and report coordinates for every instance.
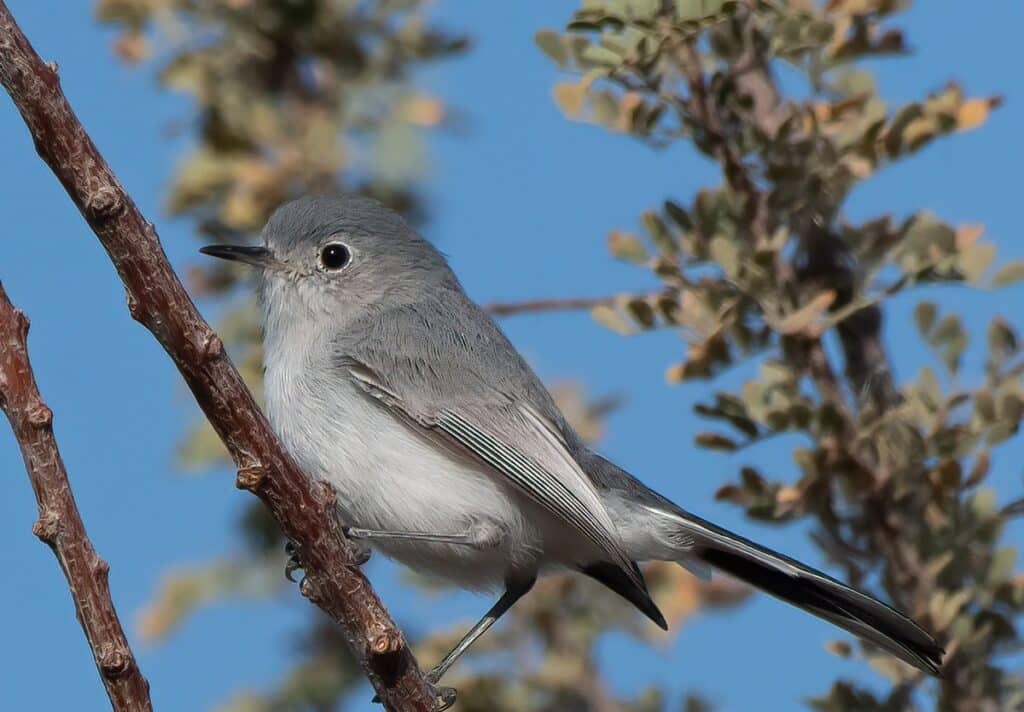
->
[0,0,1024,711]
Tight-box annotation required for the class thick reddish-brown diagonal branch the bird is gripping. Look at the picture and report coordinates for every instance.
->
[0,0,434,711]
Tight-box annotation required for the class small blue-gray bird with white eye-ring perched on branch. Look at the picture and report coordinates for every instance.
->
[203,196,943,682]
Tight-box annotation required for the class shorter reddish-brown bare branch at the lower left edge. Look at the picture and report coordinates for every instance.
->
[0,285,153,712]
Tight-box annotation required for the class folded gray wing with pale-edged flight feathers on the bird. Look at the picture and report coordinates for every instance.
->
[334,295,644,589]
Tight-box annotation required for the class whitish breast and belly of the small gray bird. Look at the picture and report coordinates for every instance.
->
[265,323,542,589]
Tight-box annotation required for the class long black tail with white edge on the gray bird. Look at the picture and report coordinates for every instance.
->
[678,512,945,676]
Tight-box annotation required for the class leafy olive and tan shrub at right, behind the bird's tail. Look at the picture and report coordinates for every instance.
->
[536,0,1024,711]
